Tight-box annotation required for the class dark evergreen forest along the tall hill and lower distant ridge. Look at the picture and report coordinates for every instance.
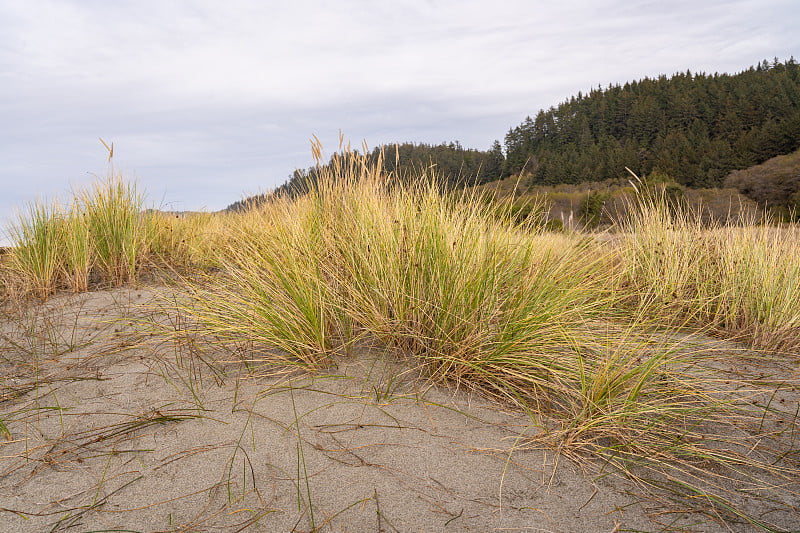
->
[228,58,800,210]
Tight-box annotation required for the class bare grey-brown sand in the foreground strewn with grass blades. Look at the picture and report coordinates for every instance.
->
[0,287,800,532]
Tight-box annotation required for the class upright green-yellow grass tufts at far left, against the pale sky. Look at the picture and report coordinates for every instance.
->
[4,173,216,300]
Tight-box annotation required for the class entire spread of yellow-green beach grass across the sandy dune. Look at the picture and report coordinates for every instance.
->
[0,141,800,529]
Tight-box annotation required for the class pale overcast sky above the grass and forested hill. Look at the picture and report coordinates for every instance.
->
[0,0,800,236]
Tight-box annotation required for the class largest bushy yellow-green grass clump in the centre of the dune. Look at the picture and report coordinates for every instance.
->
[180,141,608,382]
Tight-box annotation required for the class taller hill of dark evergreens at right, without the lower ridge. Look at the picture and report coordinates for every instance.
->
[504,58,800,187]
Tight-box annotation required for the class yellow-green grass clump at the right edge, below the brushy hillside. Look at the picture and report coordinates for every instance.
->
[618,192,800,350]
